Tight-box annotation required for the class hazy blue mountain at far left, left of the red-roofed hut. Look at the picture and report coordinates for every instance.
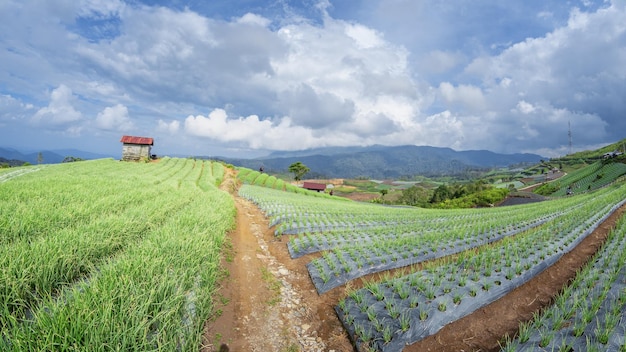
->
[0,148,112,166]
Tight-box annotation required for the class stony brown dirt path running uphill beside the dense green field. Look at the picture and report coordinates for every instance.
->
[202,169,352,352]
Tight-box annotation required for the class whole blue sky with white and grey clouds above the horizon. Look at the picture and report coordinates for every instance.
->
[0,0,626,157]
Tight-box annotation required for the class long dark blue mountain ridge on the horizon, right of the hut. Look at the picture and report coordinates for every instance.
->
[221,145,546,179]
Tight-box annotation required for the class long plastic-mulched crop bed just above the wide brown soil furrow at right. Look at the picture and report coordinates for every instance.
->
[336,187,626,351]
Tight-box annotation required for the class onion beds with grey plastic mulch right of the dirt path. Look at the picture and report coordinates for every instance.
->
[240,180,626,351]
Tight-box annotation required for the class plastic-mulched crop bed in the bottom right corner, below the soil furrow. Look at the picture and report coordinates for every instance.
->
[502,210,626,352]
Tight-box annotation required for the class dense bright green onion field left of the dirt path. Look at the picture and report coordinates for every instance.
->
[0,158,235,351]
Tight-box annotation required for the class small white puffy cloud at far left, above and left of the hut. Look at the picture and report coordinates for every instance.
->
[31,84,82,126]
